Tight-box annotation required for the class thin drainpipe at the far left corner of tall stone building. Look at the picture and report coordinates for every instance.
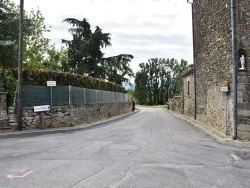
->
[187,0,197,119]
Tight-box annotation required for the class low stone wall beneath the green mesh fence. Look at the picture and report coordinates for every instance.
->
[9,103,132,129]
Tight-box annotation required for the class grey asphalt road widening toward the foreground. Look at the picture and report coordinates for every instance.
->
[0,108,250,188]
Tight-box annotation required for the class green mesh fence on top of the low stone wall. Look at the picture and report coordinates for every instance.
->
[22,86,131,107]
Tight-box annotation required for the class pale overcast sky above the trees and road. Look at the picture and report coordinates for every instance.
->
[14,0,193,72]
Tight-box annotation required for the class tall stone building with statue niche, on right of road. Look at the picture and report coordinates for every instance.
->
[189,0,250,139]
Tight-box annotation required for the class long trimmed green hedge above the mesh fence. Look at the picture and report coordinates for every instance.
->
[2,69,125,105]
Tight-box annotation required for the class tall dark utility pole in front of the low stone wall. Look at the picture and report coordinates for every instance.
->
[17,0,24,131]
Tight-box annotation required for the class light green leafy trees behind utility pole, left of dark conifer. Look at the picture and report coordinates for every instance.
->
[0,0,49,69]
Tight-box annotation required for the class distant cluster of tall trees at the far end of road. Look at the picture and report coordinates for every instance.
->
[135,58,189,105]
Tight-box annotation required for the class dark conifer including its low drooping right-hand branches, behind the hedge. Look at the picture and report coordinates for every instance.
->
[62,18,134,85]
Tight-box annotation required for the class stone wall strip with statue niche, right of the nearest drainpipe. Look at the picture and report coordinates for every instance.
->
[236,0,250,139]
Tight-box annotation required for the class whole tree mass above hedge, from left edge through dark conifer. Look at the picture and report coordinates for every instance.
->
[0,0,134,85]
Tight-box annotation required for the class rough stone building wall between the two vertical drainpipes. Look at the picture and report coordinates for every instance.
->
[194,0,233,137]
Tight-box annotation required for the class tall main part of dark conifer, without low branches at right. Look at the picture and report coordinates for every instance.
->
[62,18,111,78]
